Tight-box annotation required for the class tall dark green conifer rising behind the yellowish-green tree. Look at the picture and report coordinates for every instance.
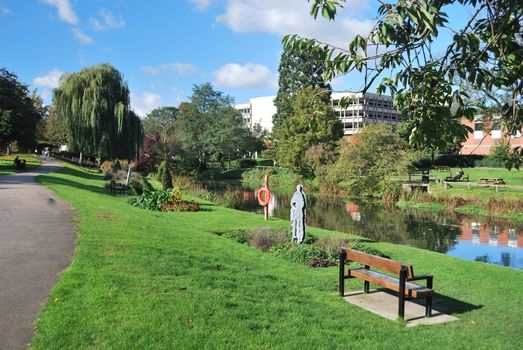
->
[272,46,331,133]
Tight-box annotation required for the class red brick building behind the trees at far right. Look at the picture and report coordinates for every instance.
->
[460,117,523,155]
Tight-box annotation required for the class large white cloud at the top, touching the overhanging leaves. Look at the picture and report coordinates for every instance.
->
[217,0,374,46]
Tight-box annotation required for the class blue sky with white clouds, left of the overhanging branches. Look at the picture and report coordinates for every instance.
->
[0,0,466,115]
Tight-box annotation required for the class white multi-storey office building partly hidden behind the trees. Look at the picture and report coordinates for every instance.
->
[235,92,401,136]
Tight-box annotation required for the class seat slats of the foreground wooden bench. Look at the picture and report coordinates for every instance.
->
[349,268,434,298]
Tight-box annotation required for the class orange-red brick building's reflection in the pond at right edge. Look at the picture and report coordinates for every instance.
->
[459,222,523,248]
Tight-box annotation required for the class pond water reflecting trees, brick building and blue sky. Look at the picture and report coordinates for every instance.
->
[208,182,523,269]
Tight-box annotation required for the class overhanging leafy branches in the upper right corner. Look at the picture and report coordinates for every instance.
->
[284,0,523,148]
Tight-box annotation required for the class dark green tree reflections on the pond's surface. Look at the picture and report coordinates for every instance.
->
[207,183,523,254]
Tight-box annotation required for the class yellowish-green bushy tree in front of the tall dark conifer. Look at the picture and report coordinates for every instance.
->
[276,87,343,175]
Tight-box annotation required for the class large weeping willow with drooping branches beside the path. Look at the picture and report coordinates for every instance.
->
[53,64,143,159]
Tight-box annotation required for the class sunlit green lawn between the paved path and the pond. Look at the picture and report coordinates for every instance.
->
[31,165,523,349]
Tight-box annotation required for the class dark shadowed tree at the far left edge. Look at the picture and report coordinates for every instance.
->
[0,68,45,148]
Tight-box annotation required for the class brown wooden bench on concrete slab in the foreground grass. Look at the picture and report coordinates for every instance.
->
[339,248,434,318]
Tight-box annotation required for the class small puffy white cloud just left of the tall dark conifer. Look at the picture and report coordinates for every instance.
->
[213,63,278,89]
